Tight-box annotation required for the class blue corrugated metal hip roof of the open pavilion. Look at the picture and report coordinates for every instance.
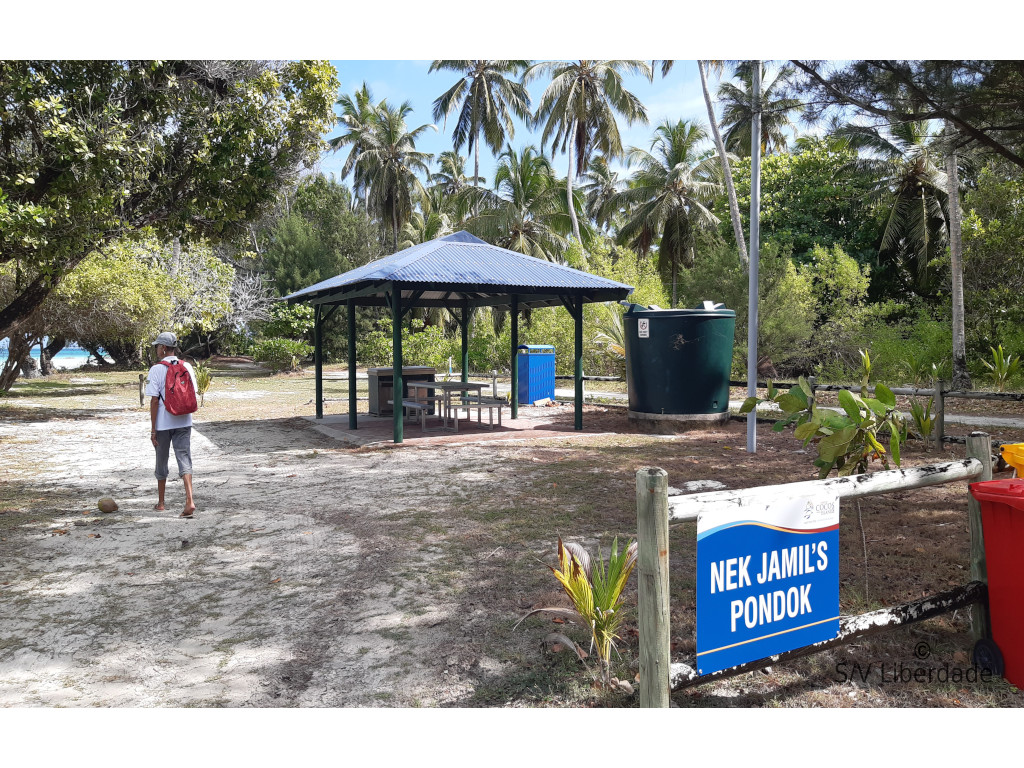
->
[285,231,633,309]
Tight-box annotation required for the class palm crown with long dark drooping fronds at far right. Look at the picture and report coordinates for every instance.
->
[835,121,949,296]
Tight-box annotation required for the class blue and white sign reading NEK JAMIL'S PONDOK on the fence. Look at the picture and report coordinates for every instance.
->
[697,495,839,675]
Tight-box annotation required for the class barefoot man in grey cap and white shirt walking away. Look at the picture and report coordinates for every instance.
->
[145,333,199,517]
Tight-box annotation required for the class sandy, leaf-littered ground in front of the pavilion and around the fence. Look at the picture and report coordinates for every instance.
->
[0,375,1024,708]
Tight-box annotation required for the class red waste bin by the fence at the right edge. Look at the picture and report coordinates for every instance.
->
[971,479,1024,688]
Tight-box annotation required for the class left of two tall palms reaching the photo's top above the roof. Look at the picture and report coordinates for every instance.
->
[428,59,529,214]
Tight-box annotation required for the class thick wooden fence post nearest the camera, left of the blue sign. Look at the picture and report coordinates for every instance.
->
[637,467,671,707]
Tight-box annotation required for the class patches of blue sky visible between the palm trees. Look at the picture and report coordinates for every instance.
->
[321,60,717,185]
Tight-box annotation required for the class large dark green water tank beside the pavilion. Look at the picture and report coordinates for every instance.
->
[624,301,736,423]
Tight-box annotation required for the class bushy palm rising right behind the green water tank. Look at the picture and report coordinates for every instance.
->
[615,120,722,306]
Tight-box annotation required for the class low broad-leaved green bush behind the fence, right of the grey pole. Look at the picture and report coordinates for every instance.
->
[739,376,906,478]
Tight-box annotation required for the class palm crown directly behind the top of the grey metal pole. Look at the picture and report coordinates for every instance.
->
[718,61,803,158]
